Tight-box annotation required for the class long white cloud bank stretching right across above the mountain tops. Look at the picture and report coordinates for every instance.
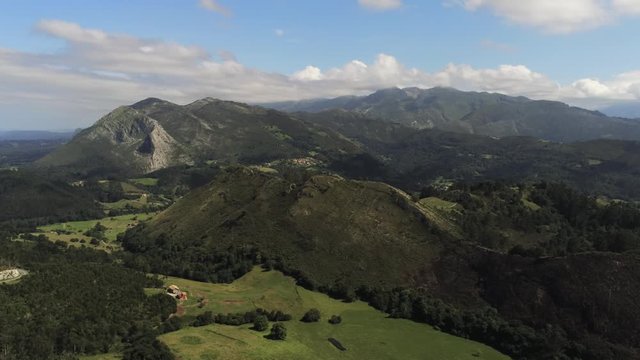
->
[0,20,640,128]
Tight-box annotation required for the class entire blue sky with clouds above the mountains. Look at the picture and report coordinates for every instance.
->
[0,0,640,130]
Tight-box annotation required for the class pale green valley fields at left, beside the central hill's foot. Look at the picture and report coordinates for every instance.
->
[36,213,155,250]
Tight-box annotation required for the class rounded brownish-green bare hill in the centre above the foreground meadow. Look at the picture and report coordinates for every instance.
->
[125,167,442,287]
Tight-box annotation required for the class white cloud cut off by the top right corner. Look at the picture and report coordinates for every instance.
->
[456,0,640,33]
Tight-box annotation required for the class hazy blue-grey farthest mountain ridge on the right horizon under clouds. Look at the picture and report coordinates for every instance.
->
[264,88,640,142]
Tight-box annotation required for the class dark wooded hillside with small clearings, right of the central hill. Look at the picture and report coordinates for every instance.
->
[438,182,640,257]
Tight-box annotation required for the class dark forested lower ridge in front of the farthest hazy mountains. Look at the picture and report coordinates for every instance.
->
[296,110,640,200]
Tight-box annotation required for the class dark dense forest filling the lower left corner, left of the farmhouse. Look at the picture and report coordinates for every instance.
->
[0,231,176,360]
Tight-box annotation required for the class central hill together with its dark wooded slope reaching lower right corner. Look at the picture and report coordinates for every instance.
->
[123,168,640,359]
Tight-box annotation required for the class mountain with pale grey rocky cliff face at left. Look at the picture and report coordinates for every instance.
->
[39,98,360,175]
